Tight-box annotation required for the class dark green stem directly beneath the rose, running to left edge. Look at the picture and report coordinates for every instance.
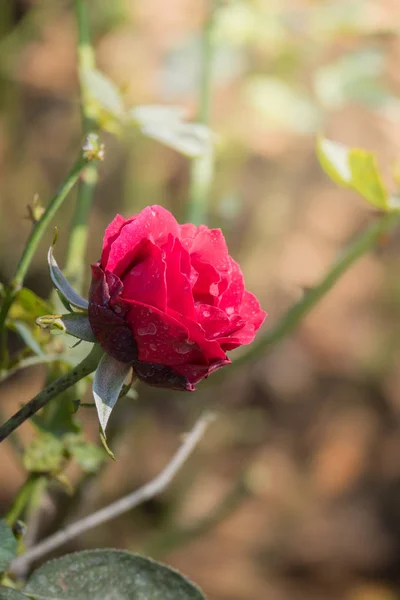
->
[0,344,102,443]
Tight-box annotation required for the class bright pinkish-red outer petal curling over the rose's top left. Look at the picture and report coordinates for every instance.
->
[106,206,180,276]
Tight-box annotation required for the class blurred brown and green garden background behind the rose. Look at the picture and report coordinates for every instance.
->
[0,0,400,600]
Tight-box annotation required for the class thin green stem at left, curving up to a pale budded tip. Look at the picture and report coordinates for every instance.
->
[0,156,87,365]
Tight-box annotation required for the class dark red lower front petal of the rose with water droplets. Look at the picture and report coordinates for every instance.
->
[127,302,208,366]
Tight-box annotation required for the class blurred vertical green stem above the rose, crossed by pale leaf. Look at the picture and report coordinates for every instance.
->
[187,0,216,225]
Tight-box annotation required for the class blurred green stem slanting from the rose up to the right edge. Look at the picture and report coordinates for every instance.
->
[230,212,400,375]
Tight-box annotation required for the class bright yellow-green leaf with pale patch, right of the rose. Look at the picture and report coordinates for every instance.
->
[317,137,392,211]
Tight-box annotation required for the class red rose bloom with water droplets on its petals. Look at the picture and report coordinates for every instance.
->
[89,206,266,390]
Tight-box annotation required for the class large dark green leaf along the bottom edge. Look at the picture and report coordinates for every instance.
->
[25,550,205,600]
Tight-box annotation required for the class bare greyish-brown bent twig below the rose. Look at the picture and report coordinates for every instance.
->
[11,413,214,572]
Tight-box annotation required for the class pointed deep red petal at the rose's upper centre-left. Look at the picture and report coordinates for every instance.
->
[122,240,167,311]
